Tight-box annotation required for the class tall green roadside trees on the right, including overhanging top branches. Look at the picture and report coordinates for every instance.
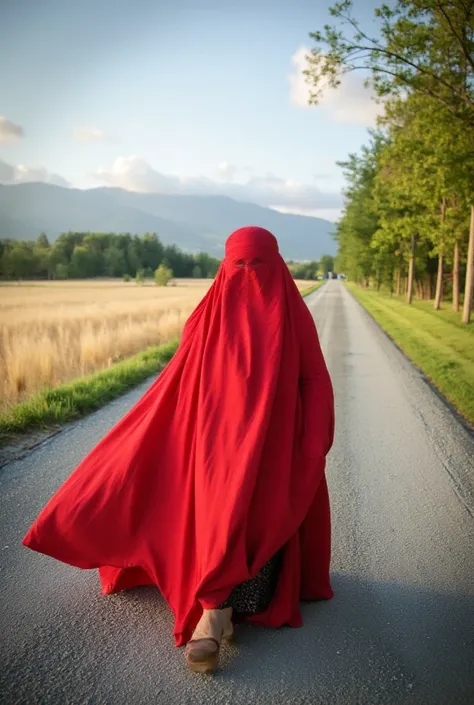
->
[307,0,474,323]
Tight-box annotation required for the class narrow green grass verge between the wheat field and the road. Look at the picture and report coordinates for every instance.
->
[0,341,178,445]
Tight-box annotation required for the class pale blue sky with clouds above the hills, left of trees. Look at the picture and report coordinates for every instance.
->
[0,0,378,219]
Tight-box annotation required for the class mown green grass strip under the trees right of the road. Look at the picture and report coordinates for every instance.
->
[347,284,474,425]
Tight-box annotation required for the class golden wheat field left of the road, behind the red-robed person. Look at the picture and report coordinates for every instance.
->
[0,279,308,411]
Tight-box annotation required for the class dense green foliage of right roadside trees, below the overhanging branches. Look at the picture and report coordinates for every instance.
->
[337,94,474,314]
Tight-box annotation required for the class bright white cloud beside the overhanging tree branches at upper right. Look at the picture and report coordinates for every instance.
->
[289,47,383,127]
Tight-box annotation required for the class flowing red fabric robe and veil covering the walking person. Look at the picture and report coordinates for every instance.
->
[23,228,334,645]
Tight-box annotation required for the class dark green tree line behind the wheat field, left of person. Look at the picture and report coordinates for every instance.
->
[0,232,220,280]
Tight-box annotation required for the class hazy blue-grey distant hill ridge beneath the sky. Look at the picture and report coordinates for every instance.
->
[0,183,336,260]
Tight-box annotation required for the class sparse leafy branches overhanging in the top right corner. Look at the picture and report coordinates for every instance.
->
[306,0,474,128]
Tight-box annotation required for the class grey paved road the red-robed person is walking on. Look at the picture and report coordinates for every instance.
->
[0,282,474,705]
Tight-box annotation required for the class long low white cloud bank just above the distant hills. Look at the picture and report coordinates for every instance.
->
[94,156,342,212]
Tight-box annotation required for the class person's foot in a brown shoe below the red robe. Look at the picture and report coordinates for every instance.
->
[186,607,234,673]
